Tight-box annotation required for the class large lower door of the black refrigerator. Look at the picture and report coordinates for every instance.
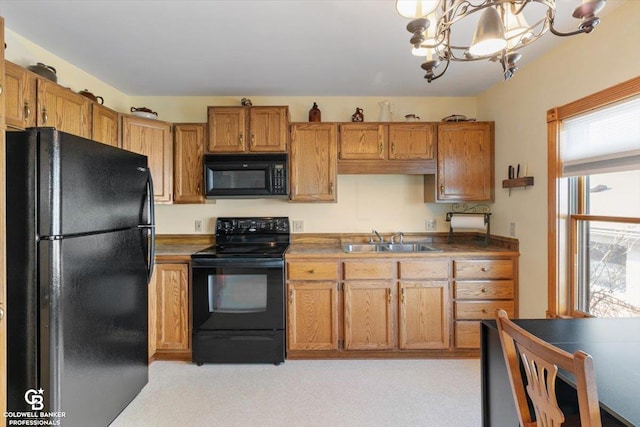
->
[39,229,148,427]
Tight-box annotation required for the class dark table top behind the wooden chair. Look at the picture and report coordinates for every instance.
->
[484,318,640,426]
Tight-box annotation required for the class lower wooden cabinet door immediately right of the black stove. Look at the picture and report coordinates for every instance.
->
[287,281,338,350]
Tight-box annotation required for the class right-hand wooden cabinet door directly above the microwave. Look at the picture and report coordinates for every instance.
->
[249,107,289,152]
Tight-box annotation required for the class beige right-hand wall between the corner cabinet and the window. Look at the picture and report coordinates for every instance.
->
[478,0,640,317]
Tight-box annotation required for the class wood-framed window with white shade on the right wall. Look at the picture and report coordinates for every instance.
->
[547,77,640,317]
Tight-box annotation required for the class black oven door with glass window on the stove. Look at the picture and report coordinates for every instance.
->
[191,258,284,333]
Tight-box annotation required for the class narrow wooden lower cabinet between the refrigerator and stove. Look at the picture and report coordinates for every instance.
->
[149,263,191,360]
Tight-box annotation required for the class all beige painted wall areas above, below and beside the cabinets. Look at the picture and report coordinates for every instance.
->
[6,0,640,317]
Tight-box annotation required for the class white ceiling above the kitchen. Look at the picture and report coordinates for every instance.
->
[0,0,622,96]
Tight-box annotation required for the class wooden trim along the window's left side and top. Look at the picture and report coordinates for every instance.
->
[546,76,640,318]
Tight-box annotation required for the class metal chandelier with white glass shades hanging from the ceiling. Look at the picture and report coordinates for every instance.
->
[396,0,606,83]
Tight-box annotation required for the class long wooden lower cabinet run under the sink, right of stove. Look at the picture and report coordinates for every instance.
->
[287,256,488,357]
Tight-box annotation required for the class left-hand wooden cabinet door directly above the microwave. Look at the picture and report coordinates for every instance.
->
[207,107,247,153]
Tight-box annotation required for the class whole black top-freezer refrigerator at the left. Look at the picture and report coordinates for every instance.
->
[6,128,155,427]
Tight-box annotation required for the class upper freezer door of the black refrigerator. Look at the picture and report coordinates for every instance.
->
[32,128,153,237]
